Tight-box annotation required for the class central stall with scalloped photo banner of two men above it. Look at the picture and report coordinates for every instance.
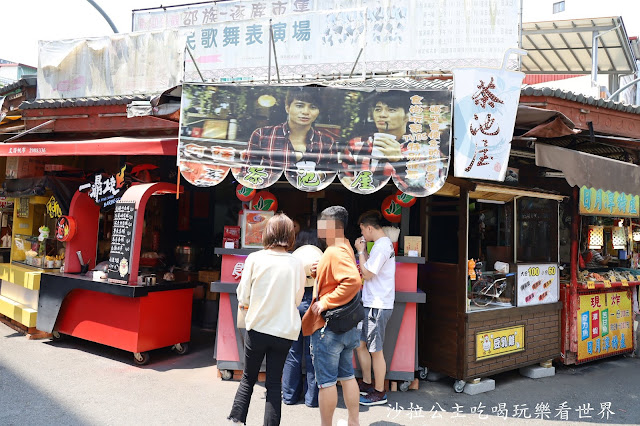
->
[178,83,442,390]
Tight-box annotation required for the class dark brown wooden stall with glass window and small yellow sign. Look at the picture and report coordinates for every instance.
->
[418,177,565,392]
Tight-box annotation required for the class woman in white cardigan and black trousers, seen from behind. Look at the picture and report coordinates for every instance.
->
[228,214,306,426]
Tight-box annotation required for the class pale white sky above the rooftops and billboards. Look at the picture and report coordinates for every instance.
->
[0,0,640,66]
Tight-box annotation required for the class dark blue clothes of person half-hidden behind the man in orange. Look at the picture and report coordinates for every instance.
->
[282,287,318,407]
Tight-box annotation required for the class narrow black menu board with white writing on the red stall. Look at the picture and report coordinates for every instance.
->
[107,201,136,284]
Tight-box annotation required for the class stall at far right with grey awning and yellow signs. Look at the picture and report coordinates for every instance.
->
[536,144,640,364]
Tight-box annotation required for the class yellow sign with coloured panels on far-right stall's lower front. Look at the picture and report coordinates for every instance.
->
[577,290,633,362]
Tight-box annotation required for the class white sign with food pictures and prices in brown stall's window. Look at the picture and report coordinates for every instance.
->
[516,263,560,306]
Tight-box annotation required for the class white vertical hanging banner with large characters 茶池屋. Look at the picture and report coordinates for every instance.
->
[453,68,524,182]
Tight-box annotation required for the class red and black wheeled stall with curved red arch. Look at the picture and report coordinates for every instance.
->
[37,183,196,365]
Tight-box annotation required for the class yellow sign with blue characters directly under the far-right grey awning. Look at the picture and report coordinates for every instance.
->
[580,186,640,217]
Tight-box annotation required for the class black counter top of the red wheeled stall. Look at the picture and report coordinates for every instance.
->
[42,272,199,297]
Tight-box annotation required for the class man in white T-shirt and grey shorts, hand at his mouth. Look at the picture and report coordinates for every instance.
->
[355,210,396,405]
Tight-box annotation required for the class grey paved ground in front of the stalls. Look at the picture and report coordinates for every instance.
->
[0,323,640,425]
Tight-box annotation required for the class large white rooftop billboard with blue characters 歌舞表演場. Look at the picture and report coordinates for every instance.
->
[133,0,520,81]
